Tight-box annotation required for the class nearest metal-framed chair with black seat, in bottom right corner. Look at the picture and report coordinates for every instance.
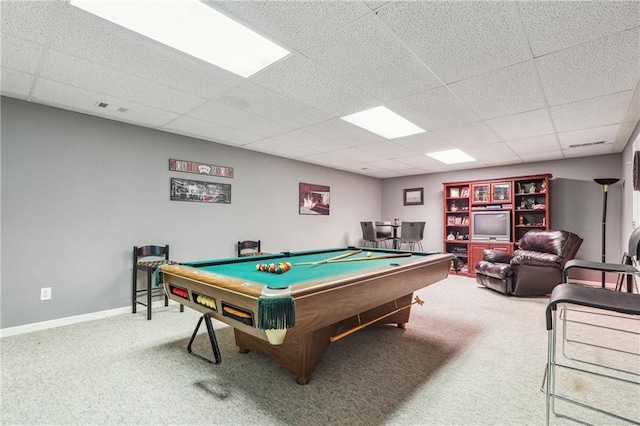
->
[542,283,640,425]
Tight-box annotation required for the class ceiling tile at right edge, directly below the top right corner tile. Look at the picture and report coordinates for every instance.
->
[535,29,640,106]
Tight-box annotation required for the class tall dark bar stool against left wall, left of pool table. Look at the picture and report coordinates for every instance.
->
[131,244,184,320]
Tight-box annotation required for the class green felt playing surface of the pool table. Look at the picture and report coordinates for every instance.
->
[187,249,436,288]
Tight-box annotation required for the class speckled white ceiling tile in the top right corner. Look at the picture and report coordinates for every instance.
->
[518,1,640,57]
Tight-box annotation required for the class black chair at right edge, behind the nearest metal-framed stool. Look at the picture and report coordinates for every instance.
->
[562,227,640,293]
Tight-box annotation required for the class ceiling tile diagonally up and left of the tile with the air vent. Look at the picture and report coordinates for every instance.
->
[485,109,554,141]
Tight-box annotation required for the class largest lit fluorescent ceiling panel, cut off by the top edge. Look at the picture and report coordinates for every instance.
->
[70,0,290,77]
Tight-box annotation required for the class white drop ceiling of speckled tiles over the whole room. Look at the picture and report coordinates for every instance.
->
[0,0,640,178]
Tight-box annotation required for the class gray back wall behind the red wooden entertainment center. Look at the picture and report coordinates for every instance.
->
[382,154,626,262]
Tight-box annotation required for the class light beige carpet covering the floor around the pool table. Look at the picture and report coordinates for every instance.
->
[0,276,640,425]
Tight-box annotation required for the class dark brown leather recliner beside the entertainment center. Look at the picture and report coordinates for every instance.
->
[475,230,582,296]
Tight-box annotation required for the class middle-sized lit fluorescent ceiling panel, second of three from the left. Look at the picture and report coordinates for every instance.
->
[342,106,425,139]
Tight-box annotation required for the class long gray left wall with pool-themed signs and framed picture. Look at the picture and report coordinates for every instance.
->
[0,98,382,328]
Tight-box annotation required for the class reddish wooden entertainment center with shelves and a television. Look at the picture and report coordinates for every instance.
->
[443,174,552,276]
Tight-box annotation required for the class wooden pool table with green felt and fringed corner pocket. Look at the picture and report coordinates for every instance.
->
[160,247,453,384]
